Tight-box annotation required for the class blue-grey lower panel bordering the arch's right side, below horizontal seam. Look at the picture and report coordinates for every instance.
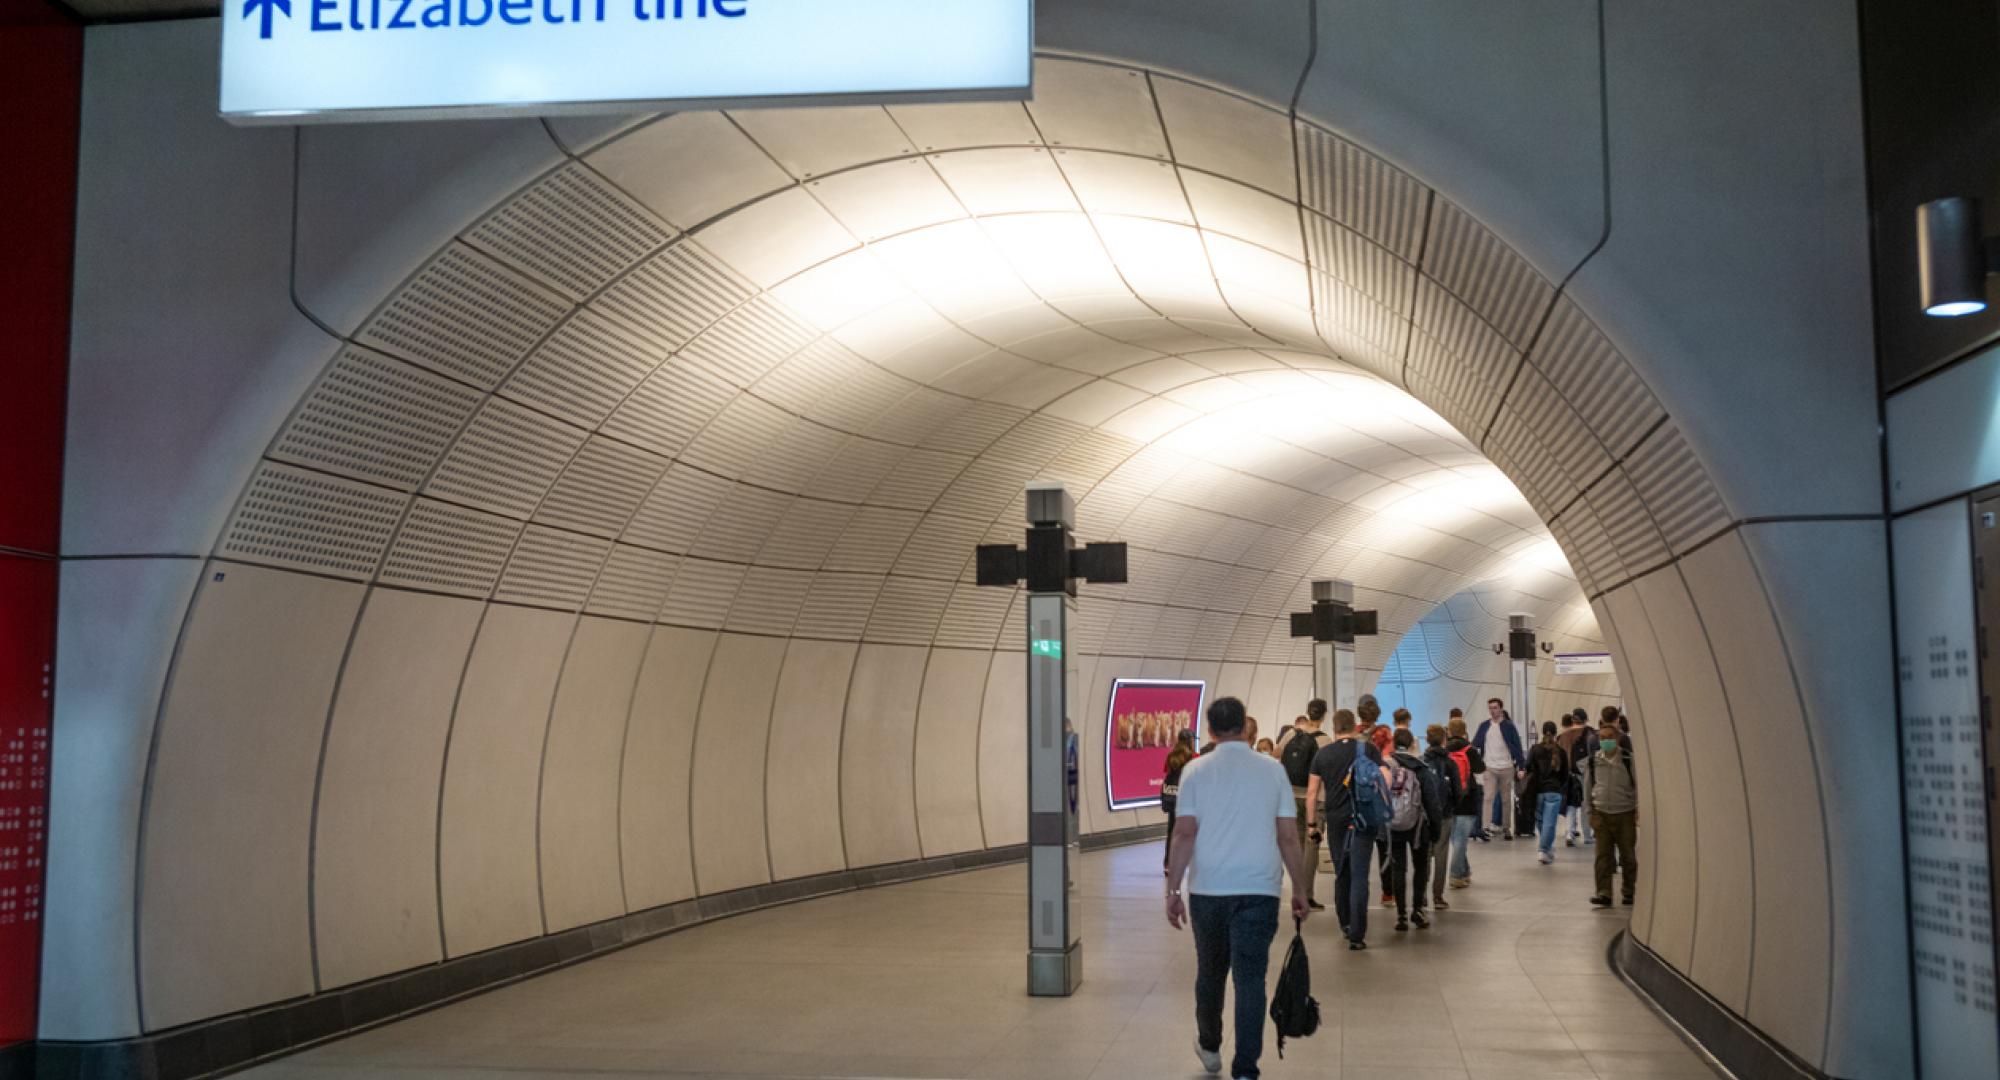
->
[1742,522,1910,1076]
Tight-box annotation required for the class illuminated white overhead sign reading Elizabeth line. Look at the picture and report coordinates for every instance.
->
[222,0,1034,124]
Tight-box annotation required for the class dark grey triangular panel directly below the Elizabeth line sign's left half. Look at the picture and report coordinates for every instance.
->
[294,120,562,334]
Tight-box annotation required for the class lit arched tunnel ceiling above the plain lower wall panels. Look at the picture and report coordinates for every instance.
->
[218,60,1726,668]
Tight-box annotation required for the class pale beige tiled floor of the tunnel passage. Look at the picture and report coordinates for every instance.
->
[246,842,1714,1080]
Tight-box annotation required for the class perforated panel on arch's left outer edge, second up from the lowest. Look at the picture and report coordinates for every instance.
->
[270,346,480,490]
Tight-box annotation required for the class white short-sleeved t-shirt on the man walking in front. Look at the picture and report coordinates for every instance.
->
[1174,742,1298,896]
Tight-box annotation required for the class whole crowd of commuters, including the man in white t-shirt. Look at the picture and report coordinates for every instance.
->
[1162,694,1638,1080]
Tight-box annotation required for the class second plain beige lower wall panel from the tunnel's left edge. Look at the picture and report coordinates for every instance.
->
[312,588,480,990]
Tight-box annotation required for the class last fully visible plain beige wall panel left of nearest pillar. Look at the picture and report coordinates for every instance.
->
[916,648,994,858]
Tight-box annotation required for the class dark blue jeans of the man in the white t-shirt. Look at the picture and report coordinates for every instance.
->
[1188,894,1278,1080]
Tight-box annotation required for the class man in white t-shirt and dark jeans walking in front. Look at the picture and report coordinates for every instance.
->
[1166,698,1312,1080]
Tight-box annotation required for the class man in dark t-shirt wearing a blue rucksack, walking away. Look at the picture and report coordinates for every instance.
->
[1306,708,1388,952]
